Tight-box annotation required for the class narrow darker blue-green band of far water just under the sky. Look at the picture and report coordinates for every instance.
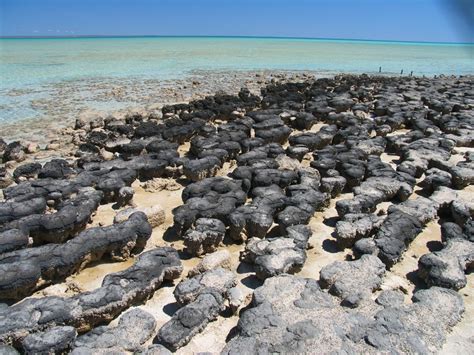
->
[0,35,474,46]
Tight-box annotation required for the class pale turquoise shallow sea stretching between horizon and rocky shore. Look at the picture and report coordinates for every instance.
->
[0,37,474,123]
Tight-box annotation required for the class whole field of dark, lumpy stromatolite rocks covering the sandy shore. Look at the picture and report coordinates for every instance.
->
[0,75,474,354]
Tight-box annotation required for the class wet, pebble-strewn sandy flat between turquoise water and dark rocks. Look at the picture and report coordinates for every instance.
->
[0,71,327,145]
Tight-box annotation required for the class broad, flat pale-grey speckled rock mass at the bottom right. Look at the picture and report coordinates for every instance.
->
[223,275,464,354]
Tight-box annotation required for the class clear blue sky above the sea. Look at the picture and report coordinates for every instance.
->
[0,0,474,42]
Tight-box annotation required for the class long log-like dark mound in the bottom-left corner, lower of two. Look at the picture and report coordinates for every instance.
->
[0,247,182,344]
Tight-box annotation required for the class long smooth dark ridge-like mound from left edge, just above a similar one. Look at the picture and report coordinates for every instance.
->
[0,212,152,299]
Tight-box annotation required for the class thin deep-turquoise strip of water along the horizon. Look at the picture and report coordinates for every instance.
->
[0,35,474,45]
